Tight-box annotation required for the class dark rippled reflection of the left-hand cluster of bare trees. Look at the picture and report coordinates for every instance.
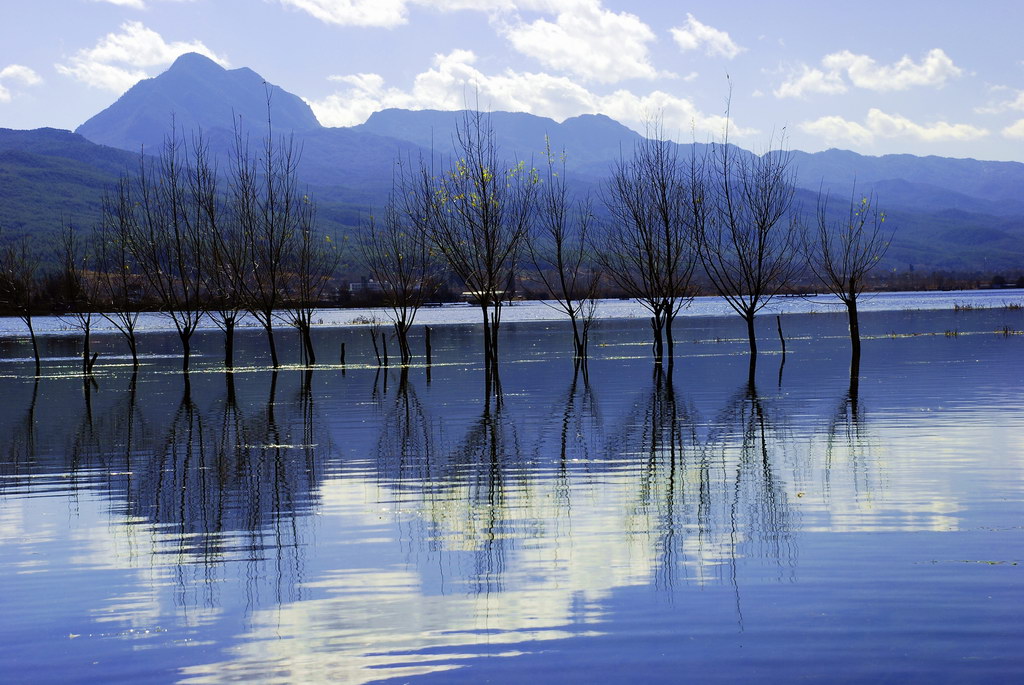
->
[3,372,331,608]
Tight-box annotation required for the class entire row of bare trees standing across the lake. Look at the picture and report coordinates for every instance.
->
[0,112,890,379]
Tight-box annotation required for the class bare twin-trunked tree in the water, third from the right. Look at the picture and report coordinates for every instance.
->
[599,122,697,363]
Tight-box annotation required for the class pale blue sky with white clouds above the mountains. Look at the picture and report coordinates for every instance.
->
[6,0,1024,162]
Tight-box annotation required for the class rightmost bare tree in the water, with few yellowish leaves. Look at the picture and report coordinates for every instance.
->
[805,186,892,359]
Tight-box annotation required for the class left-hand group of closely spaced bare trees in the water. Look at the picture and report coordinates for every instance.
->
[0,118,339,373]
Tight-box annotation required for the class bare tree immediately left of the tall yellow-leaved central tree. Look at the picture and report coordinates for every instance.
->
[359,168,437,366]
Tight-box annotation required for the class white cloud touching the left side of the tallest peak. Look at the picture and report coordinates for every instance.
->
[55,22,227,93]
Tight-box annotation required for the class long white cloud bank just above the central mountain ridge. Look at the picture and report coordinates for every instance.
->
[309,50,755,136]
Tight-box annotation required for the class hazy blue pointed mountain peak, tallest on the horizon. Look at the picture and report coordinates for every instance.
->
[75,52,321,151]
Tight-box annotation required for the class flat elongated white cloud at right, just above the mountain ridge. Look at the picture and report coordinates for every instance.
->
[800,108,989,144]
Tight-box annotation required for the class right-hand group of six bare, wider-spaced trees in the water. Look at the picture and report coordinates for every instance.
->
[362,112,891,382]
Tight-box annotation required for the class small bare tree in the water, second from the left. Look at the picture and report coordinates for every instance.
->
[59,223,99,376]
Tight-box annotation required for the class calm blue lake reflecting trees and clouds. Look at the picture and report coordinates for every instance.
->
[0,291,1024,683]
